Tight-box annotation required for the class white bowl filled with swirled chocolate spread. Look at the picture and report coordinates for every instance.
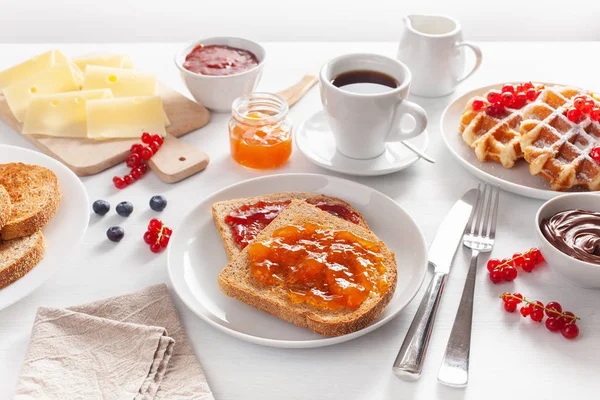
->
[535,193,600,289]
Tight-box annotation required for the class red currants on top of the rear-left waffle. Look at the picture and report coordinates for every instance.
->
[478,82,544,117]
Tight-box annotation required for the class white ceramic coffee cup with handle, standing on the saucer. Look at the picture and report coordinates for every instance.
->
[319,54,427,159]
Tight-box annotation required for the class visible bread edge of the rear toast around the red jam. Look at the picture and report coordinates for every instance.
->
[212,192,369,260]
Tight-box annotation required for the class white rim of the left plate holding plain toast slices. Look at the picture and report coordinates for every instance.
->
[0,144,90,310]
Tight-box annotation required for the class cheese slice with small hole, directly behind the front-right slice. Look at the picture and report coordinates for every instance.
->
[83,65,156,97]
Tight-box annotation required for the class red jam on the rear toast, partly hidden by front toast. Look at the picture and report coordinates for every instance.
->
[225,198,360,249]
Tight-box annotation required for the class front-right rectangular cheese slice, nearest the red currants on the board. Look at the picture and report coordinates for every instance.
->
[87,96,166,139]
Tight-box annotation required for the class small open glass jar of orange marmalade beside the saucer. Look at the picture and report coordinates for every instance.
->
[229,93,292,169]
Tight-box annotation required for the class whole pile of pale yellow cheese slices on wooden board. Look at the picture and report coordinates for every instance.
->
[0,50,169,140]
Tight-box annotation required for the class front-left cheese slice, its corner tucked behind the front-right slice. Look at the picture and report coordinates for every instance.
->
[23,89,113,138]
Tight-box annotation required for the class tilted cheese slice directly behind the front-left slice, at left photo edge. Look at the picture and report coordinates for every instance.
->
[2,63,80,122]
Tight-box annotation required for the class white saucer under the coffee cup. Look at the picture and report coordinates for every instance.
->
[294,110,429,176]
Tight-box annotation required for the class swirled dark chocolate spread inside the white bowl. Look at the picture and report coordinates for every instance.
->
[541,210,600,265]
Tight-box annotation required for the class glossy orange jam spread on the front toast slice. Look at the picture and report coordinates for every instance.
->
[248,223,389,310]
